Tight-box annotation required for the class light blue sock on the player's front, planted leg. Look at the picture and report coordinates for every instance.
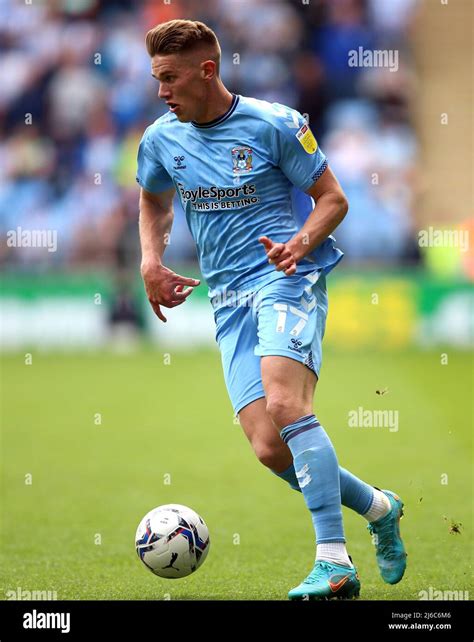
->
[281,415,346,544]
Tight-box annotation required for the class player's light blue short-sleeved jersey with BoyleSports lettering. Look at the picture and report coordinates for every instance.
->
[137,95,342,300]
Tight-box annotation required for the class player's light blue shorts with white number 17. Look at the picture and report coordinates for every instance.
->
[214,269,328,414]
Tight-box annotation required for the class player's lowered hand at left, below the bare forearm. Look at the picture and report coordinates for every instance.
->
[141,265,200,323]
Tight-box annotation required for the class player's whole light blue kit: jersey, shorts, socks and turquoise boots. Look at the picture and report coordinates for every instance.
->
[137,95,406,584]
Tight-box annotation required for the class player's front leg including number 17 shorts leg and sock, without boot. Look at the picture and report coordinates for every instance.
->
[256,272,351,566]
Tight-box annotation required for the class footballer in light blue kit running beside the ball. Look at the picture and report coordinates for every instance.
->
[137,20,406,600]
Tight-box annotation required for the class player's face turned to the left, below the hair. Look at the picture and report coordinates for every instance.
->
[151,54,206,123]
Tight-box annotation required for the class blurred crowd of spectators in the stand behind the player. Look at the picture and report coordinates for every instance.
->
[0,0,418,270]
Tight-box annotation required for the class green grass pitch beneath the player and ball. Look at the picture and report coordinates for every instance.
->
[0,348,472,600]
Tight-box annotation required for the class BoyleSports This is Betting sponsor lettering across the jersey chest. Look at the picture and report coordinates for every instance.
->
[177,182,260,211]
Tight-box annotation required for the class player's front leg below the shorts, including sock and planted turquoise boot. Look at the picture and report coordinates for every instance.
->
[261,356,360,599]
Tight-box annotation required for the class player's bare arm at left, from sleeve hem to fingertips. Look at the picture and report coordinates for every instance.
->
[139,187,199,322]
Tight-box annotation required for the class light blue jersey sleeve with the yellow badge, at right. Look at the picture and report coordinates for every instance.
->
[273,107,328,192]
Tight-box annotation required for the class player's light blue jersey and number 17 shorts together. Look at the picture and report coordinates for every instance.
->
[137,95,342,413]
